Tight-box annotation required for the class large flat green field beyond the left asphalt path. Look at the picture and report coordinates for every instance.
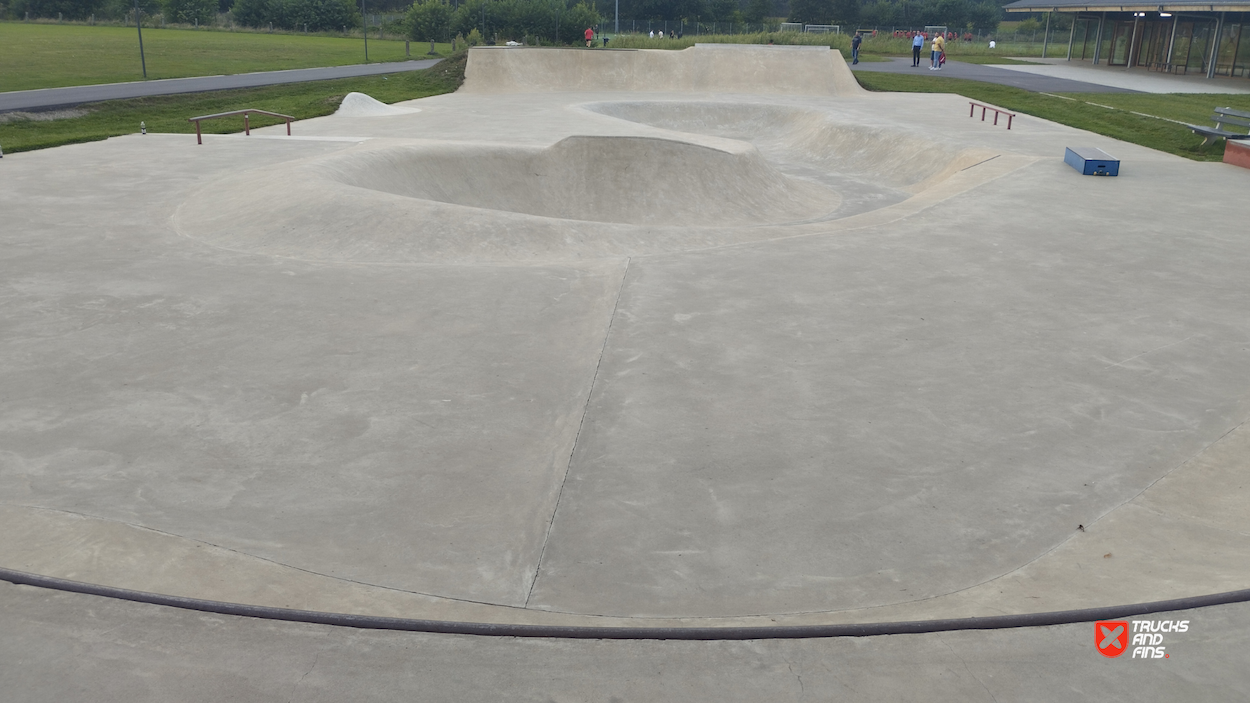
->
[0,23,451,91]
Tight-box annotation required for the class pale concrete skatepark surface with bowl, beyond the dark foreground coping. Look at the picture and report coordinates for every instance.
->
[0,45,1250,638]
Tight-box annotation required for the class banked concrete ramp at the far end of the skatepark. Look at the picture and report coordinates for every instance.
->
[460,44,864,96]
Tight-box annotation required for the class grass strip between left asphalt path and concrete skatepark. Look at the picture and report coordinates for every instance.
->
[0,53,466,154]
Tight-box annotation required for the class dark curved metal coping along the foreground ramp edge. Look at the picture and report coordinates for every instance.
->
[0,568,1250,640]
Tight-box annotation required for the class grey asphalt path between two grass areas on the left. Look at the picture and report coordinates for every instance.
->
[0,59,440,113]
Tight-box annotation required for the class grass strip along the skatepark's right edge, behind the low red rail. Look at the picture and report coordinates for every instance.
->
[855,71,1250,161]
